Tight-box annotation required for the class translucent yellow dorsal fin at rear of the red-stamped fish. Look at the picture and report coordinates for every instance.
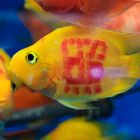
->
[97,29,140,55]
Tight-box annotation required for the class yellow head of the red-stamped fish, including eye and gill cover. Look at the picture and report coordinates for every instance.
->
[9,44,50,90]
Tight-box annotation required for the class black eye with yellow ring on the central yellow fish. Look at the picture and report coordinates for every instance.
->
[26,52,38,64]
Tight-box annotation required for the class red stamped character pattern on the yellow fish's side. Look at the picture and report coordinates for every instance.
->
[61,38,107,95]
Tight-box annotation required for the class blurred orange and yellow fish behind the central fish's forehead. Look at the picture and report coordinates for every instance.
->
[18,0,64,42]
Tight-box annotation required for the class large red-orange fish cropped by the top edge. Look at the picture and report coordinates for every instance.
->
[34,0,139,27]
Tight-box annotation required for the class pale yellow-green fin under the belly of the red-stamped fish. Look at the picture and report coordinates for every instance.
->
[57,100,98,110]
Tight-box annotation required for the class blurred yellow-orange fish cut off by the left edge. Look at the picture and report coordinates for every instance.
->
[0,49,13,120]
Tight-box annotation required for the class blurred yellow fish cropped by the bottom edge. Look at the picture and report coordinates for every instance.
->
[42,117,133,140]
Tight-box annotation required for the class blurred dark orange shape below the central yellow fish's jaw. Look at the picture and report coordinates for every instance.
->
[14,86,52,111]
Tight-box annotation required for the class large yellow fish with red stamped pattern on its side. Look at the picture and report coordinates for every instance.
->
[9,26,140,109]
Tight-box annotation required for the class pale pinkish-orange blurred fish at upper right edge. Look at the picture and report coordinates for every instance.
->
[105,3,140,33]
